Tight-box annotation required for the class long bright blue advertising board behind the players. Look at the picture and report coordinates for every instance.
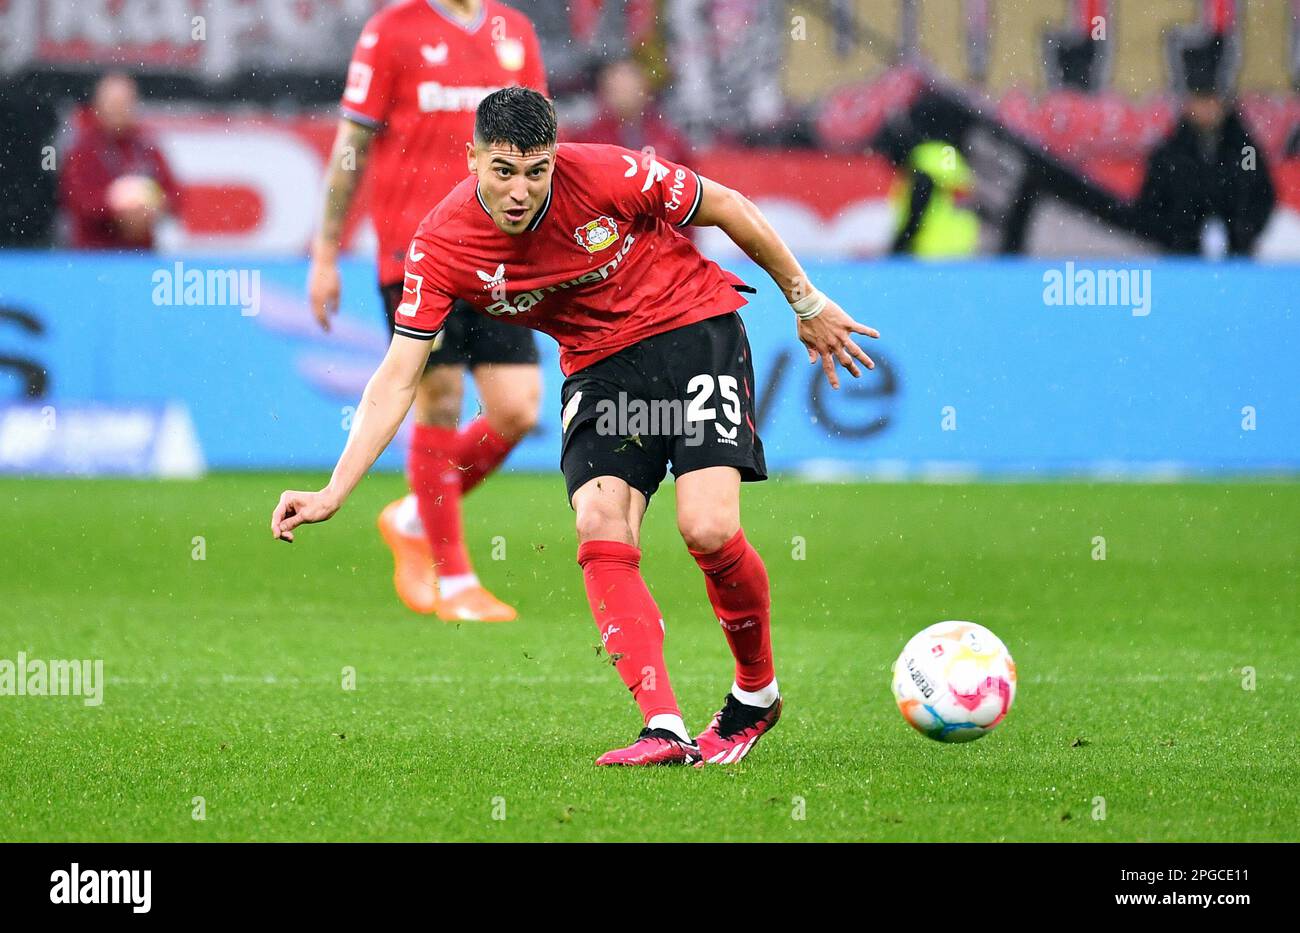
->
[0,252,1300,477]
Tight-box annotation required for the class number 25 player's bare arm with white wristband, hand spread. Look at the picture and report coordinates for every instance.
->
[689,175,880,389]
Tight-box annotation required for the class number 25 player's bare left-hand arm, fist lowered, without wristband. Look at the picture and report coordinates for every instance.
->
[270,334,429,542]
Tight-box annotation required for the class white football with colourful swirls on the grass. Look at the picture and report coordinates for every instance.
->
[893,621,1015,742]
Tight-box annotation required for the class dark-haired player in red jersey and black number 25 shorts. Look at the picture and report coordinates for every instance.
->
[270,87,878,765]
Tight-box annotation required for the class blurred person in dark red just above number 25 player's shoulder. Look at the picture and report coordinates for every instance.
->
[575,58,689,162]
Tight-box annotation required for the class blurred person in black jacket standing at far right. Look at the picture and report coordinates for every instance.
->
[1132,38,1275,256]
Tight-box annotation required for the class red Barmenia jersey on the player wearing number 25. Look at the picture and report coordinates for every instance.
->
[395,143,751,376]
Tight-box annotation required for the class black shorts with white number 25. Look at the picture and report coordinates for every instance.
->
[560,312,767,504]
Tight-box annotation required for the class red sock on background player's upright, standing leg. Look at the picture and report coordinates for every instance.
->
[407,425,473,577]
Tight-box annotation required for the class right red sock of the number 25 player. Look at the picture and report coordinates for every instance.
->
[690,529,776,691]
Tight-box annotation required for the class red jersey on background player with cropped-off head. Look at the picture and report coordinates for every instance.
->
[342,0,546,285]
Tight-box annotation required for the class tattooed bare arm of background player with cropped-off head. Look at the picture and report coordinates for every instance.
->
[307,117,374,330]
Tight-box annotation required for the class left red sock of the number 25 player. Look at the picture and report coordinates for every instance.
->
[577,541,681,722]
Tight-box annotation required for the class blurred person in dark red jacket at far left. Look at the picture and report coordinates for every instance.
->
[59,73,179,249]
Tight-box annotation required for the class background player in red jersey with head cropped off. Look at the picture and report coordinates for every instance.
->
[308,0,546,621]
